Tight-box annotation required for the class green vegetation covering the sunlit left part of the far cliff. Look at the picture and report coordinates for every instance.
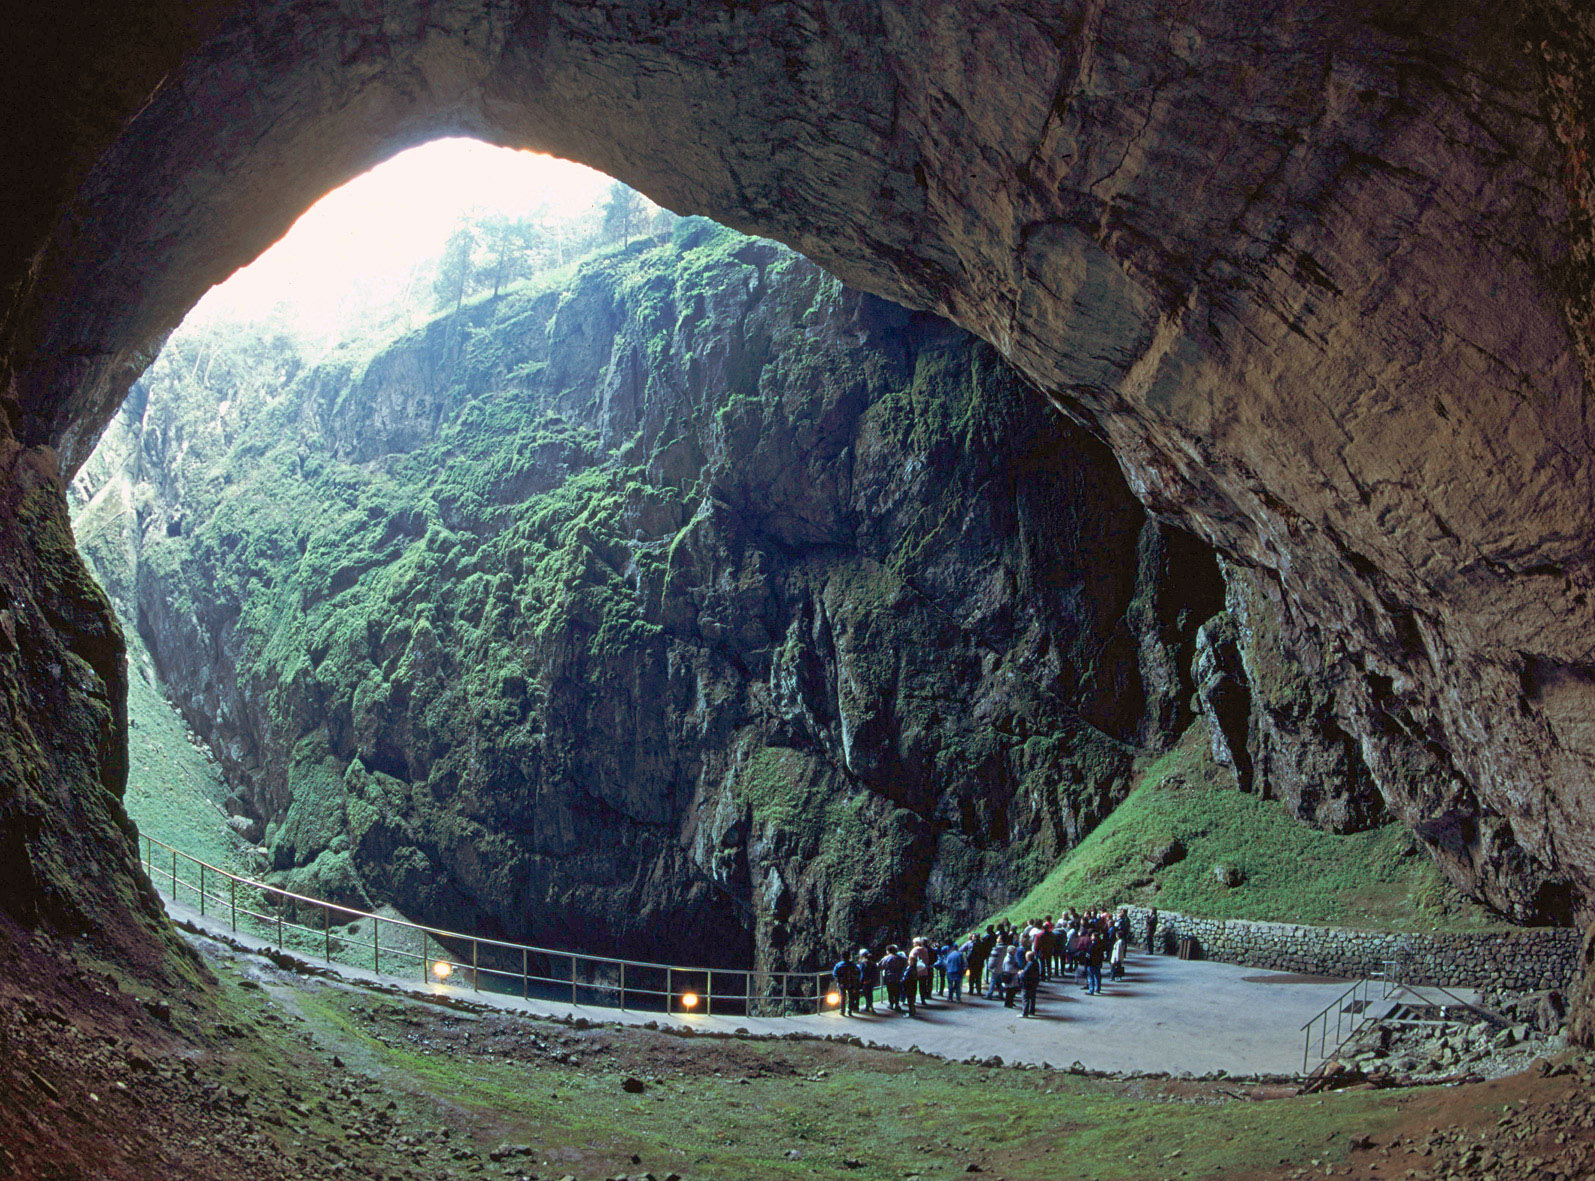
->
[83,218,836,903]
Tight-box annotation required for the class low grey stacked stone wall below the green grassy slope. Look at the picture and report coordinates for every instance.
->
[1129,906,1581,993]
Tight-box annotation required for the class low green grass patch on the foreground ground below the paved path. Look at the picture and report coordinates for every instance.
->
[277,991,1399,1181]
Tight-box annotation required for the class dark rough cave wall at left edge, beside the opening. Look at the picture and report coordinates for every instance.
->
[0,423,175,980]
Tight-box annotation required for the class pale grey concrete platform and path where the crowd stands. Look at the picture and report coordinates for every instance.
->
[163,899,1378,1074]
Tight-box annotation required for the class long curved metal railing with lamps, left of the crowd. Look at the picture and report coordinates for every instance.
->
[144,836,839,1017]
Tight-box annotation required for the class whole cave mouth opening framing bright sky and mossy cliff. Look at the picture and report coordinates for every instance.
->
[78,113,1220,966]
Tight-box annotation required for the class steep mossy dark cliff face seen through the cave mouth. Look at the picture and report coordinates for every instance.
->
[71,222,1223,962]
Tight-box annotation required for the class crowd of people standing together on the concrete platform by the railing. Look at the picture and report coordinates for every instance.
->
[831,910,1158,1017]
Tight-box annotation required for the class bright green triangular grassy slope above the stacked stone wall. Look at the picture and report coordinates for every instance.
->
[995,723,1493,930]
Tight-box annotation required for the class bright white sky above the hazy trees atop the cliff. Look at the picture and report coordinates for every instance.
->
[188,139,611,335]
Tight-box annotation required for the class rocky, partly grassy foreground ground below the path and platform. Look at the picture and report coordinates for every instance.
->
[0,912,1595,1181]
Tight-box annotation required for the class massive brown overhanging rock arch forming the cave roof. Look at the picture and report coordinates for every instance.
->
[0,0,1595,995]
